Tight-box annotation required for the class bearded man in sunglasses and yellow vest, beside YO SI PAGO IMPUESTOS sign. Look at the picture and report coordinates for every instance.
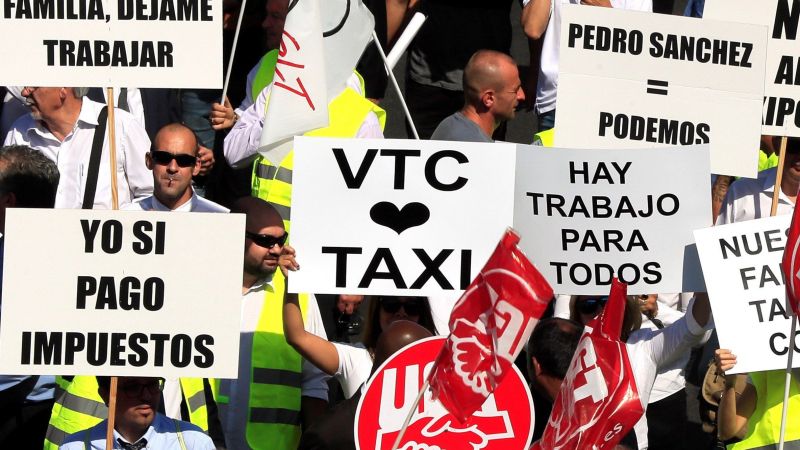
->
[217,197,328,450]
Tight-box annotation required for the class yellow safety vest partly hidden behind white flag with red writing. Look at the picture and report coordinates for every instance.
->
[251,74,386,232]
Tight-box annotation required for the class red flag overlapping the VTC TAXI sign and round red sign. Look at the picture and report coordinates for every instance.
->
[428,229,553,422]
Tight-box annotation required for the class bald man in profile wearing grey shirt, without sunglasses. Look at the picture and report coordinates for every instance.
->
[431,50,525,142]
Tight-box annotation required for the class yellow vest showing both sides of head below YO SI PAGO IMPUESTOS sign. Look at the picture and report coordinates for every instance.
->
[44,375,208,450]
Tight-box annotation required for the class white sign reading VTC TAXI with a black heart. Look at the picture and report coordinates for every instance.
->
[289,137,515,295]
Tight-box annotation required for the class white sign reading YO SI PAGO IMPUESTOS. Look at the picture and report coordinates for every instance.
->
[0,209,244,378]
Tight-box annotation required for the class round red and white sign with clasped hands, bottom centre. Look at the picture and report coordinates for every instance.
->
[354,337,534,450]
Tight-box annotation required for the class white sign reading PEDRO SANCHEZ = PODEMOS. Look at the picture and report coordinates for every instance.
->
[554,6,767,178]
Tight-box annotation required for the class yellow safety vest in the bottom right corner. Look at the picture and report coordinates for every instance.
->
[728,370,800,450]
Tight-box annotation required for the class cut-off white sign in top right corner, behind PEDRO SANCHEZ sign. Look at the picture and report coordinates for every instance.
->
[703,0,800,137]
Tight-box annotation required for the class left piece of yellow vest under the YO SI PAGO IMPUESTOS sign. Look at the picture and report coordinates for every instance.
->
[44,375,108,450]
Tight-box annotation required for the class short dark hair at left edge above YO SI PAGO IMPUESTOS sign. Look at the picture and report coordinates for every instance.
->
[0,145,59,208]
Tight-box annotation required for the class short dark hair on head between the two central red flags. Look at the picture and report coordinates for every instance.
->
[528,317,583,380]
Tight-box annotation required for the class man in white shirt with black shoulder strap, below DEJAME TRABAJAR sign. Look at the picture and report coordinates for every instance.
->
[5,87,153,209]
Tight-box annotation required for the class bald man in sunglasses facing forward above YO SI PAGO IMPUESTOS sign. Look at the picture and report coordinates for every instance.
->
[122,123,228,212]
